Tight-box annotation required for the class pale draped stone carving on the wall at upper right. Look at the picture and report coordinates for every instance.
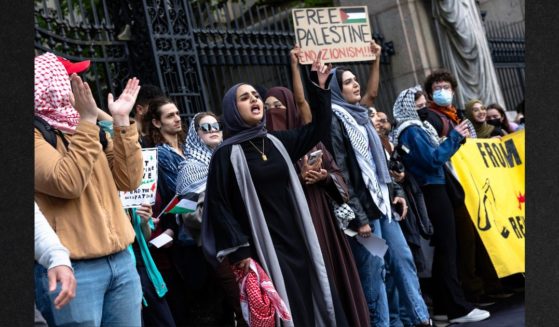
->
[432,0,504,108]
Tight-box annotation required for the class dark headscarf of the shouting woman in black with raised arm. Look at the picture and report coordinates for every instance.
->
[218,83,267,148]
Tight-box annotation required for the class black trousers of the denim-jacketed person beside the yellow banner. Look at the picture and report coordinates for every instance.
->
[421,185,474,319]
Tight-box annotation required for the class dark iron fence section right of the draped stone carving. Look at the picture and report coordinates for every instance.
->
[484,21,526,110]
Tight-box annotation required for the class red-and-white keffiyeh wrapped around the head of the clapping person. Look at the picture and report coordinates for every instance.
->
[35,53,80,134]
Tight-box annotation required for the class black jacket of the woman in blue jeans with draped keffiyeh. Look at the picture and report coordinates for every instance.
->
[330,115,404,230]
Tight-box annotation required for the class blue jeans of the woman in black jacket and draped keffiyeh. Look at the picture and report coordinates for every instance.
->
[350,217,429,326]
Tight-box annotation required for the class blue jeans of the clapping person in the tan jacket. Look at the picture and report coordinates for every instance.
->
[35,250,142,327]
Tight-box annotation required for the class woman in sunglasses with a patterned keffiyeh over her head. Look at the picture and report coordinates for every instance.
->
[176,112,246,326]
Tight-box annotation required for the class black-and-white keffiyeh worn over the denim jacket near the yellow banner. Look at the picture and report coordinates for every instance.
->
[392,86,439,146]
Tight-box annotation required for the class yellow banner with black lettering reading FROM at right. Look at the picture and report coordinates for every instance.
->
[451,130,526,277]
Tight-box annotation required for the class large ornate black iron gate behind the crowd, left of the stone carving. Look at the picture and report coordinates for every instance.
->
[35,0,395,118]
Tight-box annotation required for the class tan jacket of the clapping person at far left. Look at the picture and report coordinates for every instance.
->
[35,121,143,260]
